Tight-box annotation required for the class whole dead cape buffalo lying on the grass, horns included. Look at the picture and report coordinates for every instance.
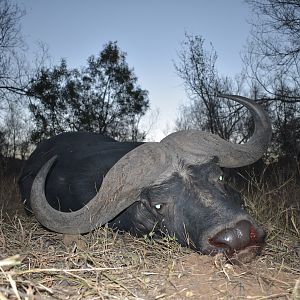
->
[20,95,271,259]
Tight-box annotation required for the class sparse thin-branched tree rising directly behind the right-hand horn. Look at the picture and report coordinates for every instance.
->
[175,34,253,141]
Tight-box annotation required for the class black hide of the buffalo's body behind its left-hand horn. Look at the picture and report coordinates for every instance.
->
[19,132,141,211]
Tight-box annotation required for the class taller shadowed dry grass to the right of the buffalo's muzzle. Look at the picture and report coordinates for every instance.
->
[244,163,300,270]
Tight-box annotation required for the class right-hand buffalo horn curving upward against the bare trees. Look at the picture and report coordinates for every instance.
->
[161,95,272,168]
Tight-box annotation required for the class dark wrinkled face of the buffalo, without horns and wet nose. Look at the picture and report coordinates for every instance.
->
[109,161,265,256]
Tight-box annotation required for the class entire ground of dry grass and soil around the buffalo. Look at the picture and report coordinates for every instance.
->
[0,163,300,300]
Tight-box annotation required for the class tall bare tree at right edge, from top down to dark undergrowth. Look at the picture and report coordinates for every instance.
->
[243,0,300,157]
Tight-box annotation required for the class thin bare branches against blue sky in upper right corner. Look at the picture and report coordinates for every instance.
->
[244,0,300,101]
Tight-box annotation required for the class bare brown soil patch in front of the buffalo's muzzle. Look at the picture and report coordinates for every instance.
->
[163,253,300,299]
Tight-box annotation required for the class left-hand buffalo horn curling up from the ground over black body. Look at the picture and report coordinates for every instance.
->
[30,143,172,234]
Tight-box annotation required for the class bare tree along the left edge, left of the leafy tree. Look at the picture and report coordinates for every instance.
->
[0,0,29,157]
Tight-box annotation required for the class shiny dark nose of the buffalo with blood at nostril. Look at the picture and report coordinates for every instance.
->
[209,220,263,251]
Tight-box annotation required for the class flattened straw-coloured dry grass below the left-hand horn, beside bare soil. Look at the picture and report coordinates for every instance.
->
[0,217,192,299]
